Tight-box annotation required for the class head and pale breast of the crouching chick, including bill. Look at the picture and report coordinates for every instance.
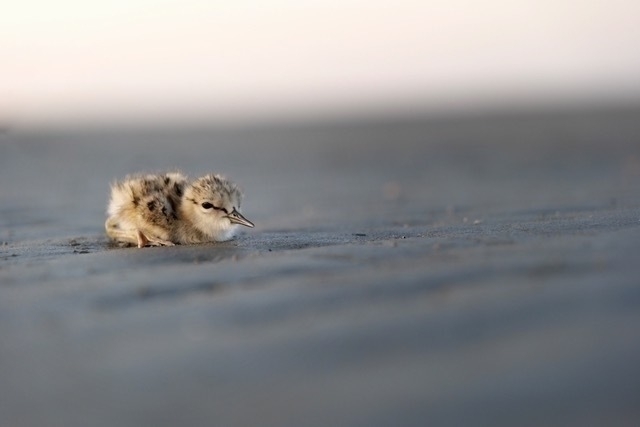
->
[173,174,254,243]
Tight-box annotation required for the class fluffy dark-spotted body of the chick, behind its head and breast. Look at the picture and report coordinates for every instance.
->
[105,172,187,248]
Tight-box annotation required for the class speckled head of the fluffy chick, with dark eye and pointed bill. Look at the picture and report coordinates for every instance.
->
[183,174,254,240]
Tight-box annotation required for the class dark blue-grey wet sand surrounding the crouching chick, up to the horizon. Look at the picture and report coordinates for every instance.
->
[0,108,640,427]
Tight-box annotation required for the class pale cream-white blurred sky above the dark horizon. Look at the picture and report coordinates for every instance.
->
[0,0,640,124]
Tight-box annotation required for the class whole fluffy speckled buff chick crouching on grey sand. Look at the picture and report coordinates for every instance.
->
[105,172,254,248]
